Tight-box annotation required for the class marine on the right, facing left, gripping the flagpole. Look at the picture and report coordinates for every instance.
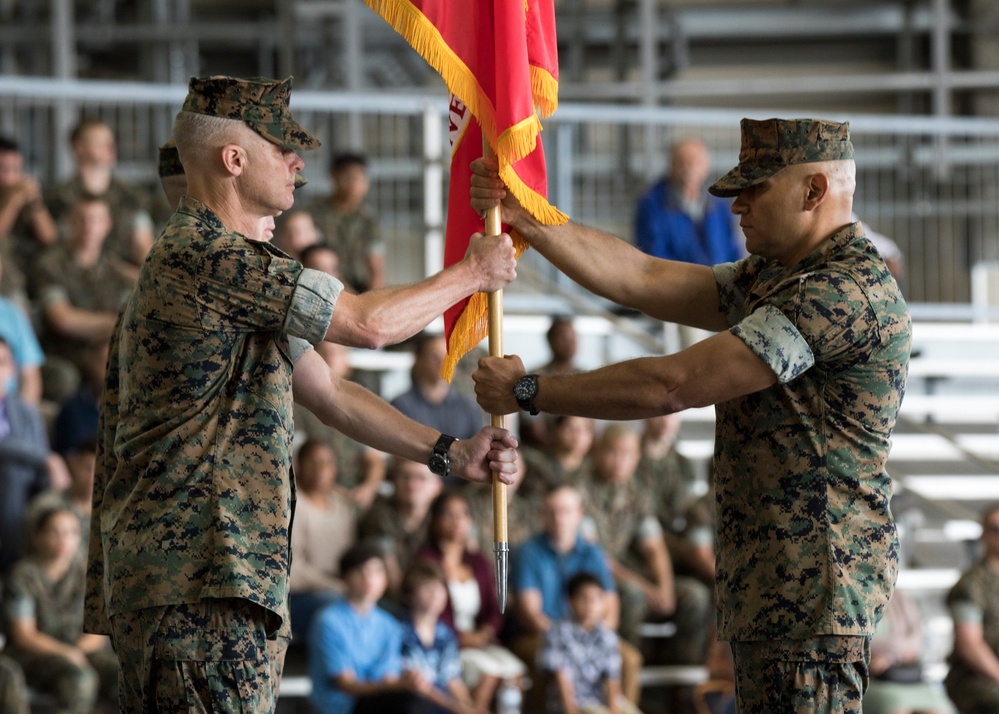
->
[472,119,911,714]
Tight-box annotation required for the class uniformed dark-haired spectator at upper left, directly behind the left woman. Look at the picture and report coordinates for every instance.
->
[45,117,154,268]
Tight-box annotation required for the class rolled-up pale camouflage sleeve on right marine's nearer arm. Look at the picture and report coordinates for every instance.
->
[730,305,815,384]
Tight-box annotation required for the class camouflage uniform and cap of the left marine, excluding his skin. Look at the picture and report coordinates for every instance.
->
[85,77,328,712]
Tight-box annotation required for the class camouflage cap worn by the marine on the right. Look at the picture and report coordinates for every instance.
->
[708,119,853,196]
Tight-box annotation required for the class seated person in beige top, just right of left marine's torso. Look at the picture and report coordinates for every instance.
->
[288,440,357,636]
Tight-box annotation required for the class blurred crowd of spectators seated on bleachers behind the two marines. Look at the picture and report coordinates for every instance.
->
[0,118,984,714]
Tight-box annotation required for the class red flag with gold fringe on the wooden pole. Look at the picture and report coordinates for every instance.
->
[365,0,568,379]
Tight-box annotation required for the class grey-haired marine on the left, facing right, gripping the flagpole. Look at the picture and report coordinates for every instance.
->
[85,77,516,712]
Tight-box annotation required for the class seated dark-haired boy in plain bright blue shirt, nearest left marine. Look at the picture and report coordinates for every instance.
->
[308,544,429,714]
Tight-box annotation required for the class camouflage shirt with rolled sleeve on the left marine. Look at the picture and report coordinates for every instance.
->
[86,197,340,633]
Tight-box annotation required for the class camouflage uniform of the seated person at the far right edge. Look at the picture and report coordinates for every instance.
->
[944,561,999,714]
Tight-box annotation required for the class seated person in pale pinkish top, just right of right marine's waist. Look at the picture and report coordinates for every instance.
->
[864,588,950,714]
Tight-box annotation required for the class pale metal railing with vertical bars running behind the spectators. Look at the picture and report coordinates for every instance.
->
[0,77,999,316]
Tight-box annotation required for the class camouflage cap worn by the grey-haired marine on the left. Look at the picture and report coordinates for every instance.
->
[181,75,319,150]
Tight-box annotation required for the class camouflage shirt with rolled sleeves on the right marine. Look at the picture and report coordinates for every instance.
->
[714,223,912,640]
